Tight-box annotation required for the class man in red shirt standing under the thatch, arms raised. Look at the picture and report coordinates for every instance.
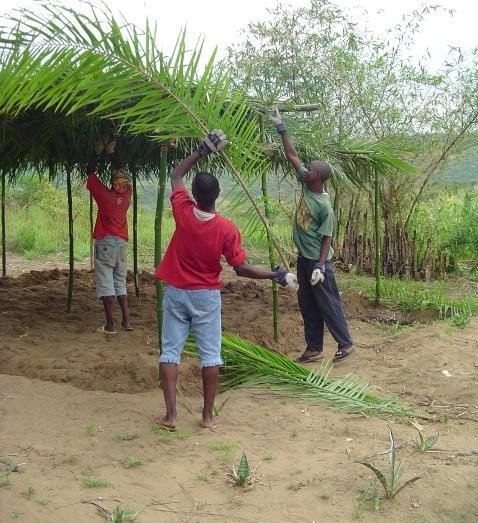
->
[86,139,133,334]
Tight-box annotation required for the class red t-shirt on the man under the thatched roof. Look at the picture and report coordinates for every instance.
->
[86,172,131,241]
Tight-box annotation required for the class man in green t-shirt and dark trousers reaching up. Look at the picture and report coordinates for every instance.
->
[270,108,353,363]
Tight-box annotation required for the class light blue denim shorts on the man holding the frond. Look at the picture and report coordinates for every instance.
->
[159,285,223,367]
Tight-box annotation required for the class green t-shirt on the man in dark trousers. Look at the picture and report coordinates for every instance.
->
[293,165,335,260]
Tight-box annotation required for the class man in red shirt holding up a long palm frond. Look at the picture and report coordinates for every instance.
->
[155,129,296,429]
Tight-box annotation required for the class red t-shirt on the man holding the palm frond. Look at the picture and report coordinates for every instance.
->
[155,188,246,290]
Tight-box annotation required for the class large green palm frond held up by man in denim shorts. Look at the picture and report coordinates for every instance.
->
[0,3,287,265]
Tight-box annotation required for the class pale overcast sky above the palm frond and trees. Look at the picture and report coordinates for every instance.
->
[0,0,478,67]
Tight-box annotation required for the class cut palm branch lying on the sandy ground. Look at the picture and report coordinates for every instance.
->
[185,332,419,416]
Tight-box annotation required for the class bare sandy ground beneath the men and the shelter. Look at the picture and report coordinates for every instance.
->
[0,269,478,523]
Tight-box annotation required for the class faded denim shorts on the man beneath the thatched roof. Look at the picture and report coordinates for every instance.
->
[95,236,128,298]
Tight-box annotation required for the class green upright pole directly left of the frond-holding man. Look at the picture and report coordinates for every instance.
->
[154,145,168,350]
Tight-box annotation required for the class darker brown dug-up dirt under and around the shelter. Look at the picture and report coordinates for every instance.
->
[0,269,436,394]
